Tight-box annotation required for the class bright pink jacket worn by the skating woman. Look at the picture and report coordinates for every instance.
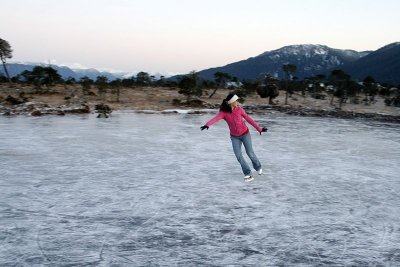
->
[206,107,262,136]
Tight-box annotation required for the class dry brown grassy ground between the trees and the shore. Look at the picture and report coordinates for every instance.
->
[0,84,400,116]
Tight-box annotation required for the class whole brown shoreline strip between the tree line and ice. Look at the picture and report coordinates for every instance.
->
[0,87,400,123]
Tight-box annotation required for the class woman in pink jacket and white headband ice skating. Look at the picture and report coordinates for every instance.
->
[200,94,268,182]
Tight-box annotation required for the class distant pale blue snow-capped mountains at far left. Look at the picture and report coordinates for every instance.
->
[0,63,119,81]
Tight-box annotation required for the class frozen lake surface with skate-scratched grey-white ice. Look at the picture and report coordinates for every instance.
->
[0,113,400,266]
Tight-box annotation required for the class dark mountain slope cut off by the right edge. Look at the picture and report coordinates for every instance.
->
[343,42,400,84]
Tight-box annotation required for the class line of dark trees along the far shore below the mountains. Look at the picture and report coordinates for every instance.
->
[0,39,400,108]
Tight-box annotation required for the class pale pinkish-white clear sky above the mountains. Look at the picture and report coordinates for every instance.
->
[0,0,400,75]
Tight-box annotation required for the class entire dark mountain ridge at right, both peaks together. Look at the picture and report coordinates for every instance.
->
[199,42,400,83]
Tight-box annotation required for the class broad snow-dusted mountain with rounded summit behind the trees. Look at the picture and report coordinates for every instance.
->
[199,44,369,80]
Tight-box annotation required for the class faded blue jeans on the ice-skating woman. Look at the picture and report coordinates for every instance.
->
[231,133,261,175]
